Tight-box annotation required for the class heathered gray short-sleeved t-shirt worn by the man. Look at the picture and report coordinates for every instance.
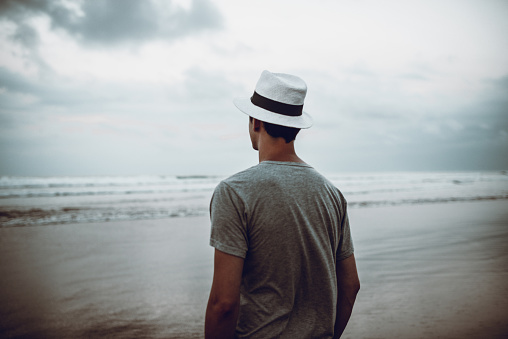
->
[210,161,353,338]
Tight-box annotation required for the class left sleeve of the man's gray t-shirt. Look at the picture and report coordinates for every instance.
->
[210,182,248,258]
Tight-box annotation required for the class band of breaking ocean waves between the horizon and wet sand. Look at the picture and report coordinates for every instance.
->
[0,171,508,227]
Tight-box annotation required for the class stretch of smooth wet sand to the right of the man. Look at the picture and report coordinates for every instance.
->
[343,201,508,339]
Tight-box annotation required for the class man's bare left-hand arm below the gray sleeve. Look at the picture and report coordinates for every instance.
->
[205,249,243,339]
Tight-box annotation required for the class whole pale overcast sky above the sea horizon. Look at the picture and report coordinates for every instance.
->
[0,0,508,175]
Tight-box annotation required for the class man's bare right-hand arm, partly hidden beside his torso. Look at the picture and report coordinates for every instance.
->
[333,254,360,338]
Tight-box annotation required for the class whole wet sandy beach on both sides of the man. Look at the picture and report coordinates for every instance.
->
[0,201,508,338]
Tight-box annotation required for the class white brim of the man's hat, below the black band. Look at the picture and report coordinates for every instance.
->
[233,98,312,129]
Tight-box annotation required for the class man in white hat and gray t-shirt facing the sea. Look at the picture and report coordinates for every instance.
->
[205,71,360,338]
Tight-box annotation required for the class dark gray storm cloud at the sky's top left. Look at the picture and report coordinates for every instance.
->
[0,0,221,45]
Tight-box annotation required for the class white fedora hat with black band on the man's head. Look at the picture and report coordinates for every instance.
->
[233,71,312,128]
